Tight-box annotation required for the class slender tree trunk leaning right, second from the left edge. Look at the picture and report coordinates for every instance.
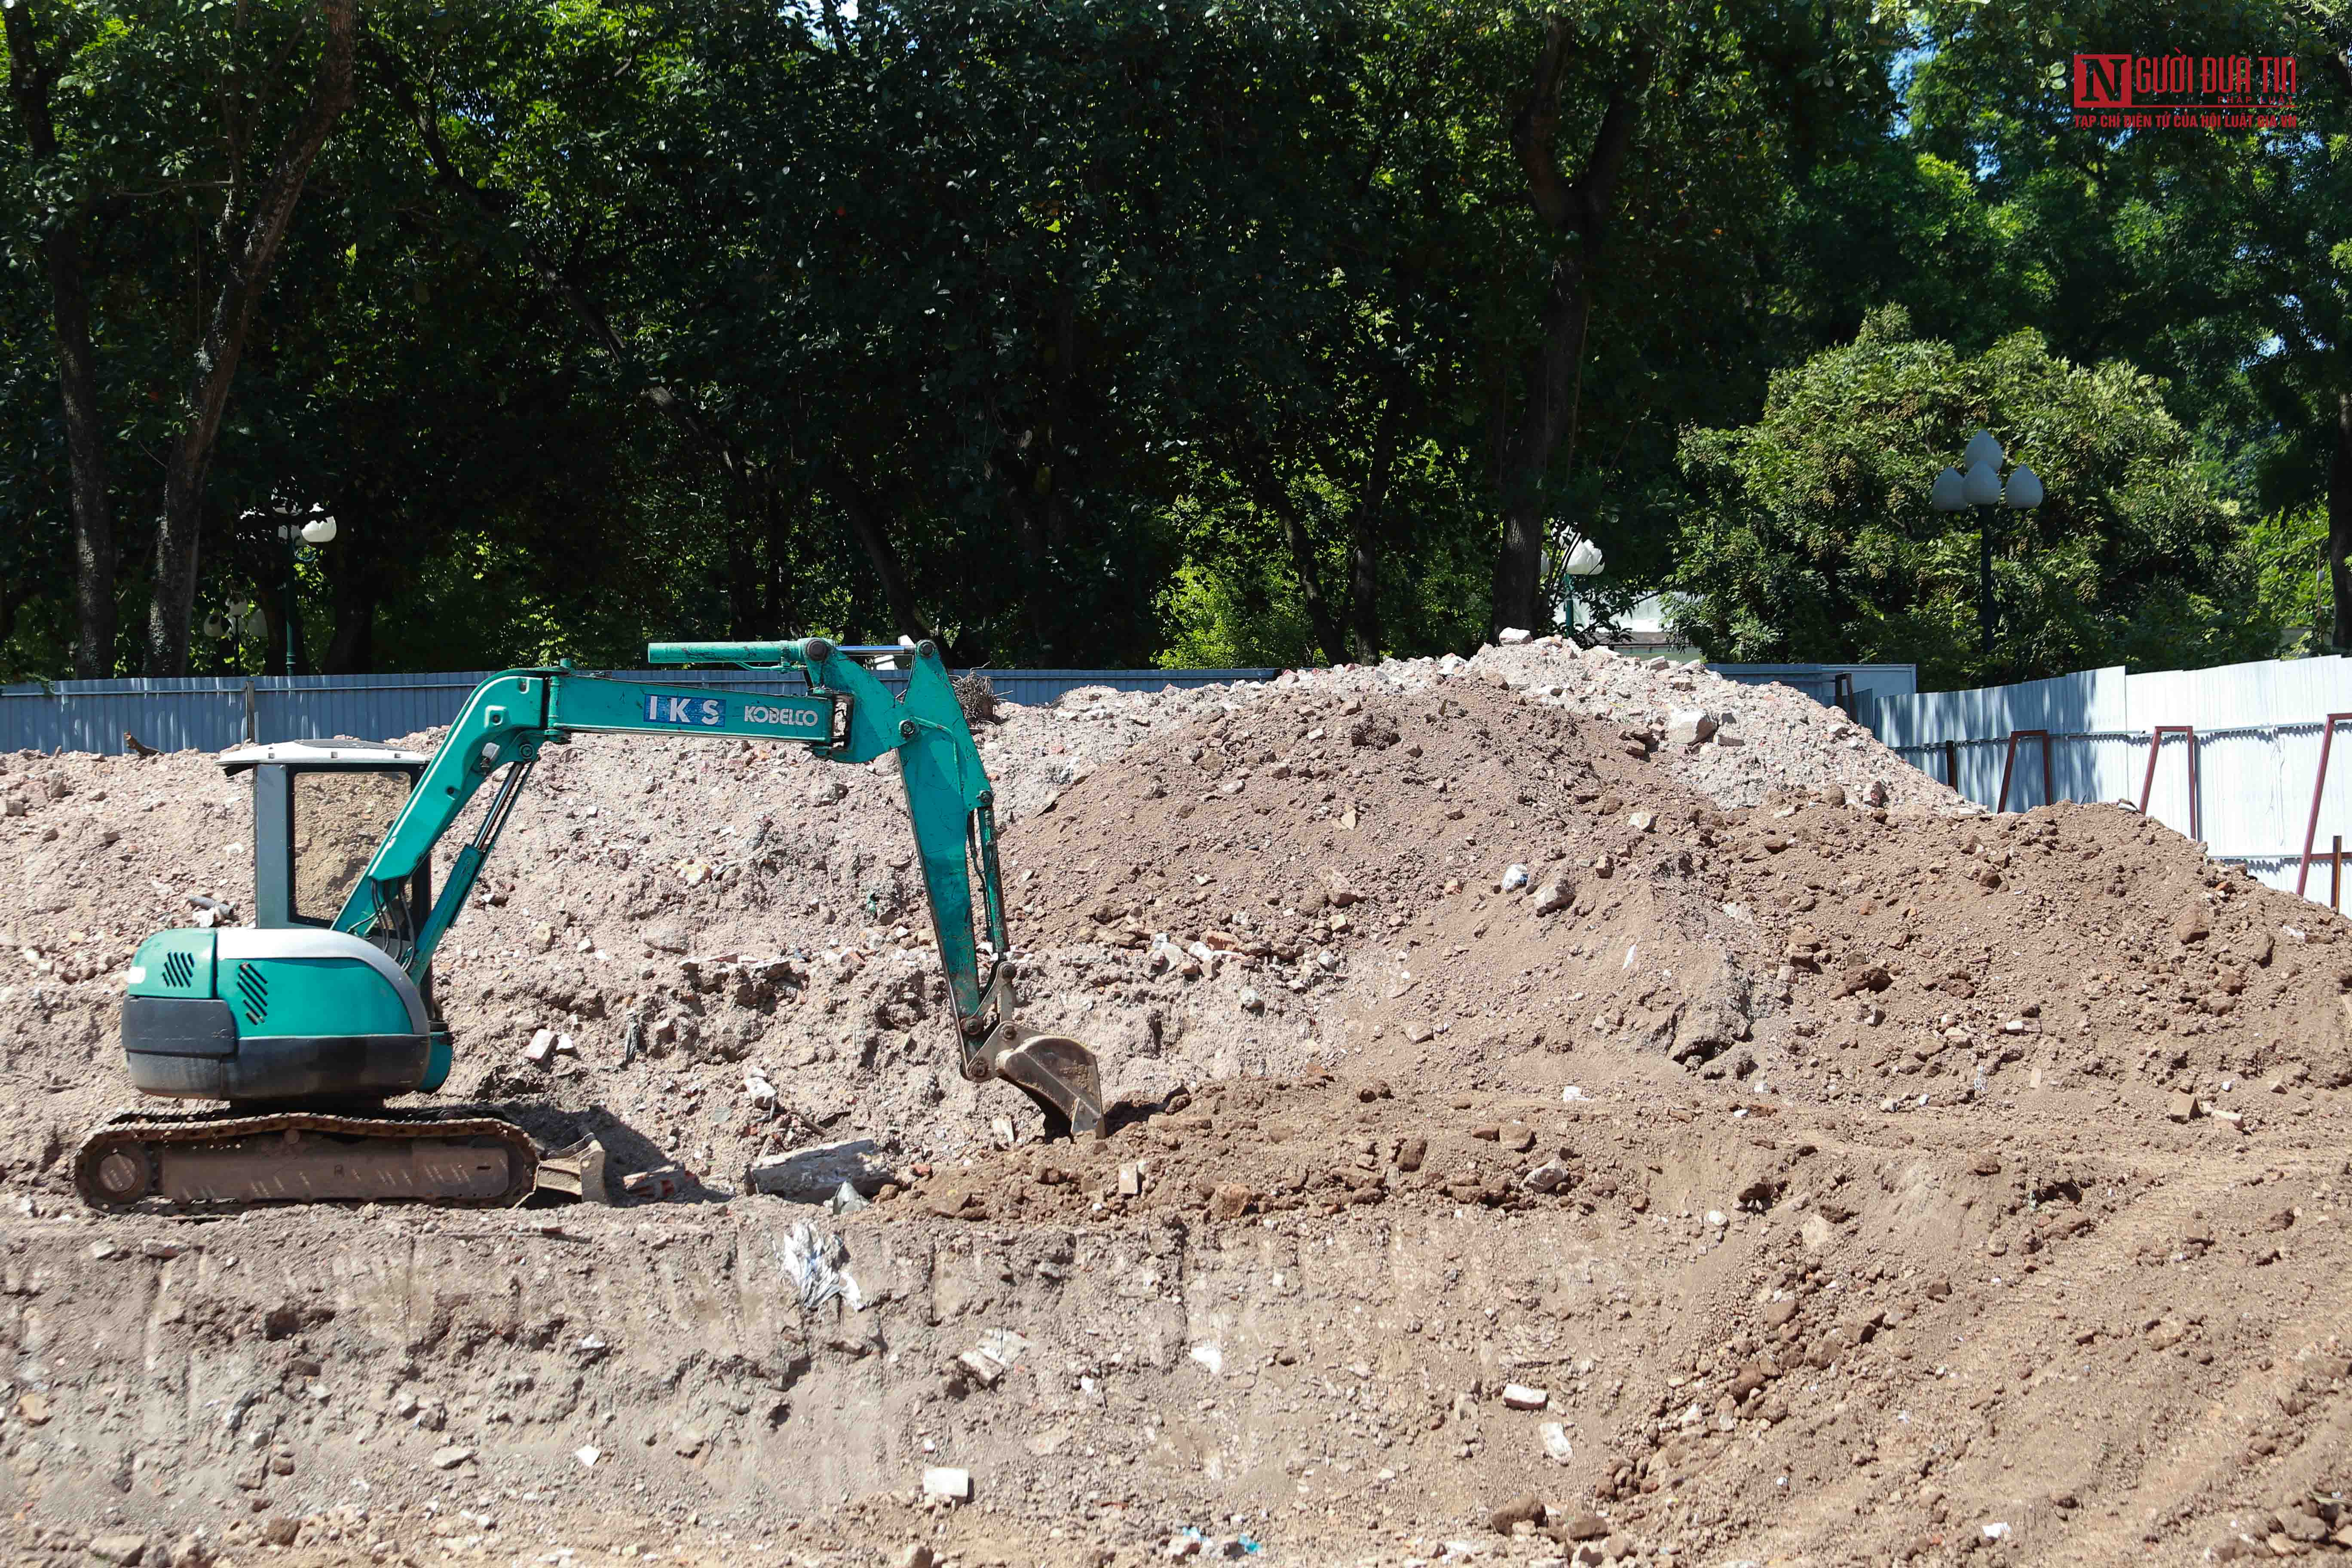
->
[146,0,358,675]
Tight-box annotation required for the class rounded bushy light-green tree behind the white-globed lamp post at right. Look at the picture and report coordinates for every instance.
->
[1675,312,2279,689]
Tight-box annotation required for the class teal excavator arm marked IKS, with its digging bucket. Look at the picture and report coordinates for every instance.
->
[334,637,1103,1138]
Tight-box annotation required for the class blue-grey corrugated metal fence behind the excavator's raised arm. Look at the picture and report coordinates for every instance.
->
[0,670,1280,752]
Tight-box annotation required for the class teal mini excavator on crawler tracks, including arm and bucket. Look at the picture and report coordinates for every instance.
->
[75,637,1103,1208]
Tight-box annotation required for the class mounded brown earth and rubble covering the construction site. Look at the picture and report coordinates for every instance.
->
[0,644,2352,1568]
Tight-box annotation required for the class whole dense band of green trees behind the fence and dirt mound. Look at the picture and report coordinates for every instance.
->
[0,0,2352,680]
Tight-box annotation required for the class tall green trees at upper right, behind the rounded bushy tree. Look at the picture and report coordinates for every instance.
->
[1886,0,2352,642]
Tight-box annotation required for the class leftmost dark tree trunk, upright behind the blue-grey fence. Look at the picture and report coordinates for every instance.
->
[0,0,115,680]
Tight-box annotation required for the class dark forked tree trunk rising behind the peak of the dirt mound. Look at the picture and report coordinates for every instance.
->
[1494,16,1644,632]
